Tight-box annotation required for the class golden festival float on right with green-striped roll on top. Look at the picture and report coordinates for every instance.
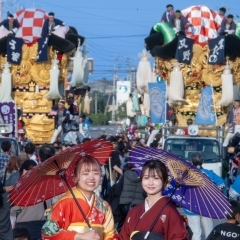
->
[137,5,240,135]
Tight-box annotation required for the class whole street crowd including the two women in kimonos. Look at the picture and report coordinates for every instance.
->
[0,119,240,240]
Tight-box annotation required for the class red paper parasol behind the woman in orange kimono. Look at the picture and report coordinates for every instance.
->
[9,140,112,207]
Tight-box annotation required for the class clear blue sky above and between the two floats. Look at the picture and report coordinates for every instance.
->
[3,0,240,81]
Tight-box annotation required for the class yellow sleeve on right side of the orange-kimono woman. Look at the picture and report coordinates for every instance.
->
[103,206,119,240]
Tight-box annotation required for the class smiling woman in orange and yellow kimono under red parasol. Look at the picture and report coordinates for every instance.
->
[42,156,118,240]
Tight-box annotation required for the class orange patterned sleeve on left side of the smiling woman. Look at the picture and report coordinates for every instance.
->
[42,203,76,240]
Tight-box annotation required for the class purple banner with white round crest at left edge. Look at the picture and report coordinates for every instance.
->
[0,102,17,137]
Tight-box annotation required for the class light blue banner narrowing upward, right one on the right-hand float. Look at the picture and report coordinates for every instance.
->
[195,86,216,125]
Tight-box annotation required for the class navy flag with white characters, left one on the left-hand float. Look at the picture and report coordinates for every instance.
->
[7,36,23,65]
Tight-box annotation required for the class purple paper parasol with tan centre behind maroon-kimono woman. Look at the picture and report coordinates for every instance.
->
[130,147,231,219]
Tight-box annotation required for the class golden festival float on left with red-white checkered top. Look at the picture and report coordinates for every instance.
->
[0,9,89,144]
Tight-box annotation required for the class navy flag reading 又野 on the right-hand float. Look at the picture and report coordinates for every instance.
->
[175,36,194,64]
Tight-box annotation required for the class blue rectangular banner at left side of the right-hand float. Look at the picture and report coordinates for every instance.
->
[148,81,167,123]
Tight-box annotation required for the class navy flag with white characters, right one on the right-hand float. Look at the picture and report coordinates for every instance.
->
[208,36,225,64]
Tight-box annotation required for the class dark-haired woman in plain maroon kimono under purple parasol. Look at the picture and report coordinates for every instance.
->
[120,160,187,240]
